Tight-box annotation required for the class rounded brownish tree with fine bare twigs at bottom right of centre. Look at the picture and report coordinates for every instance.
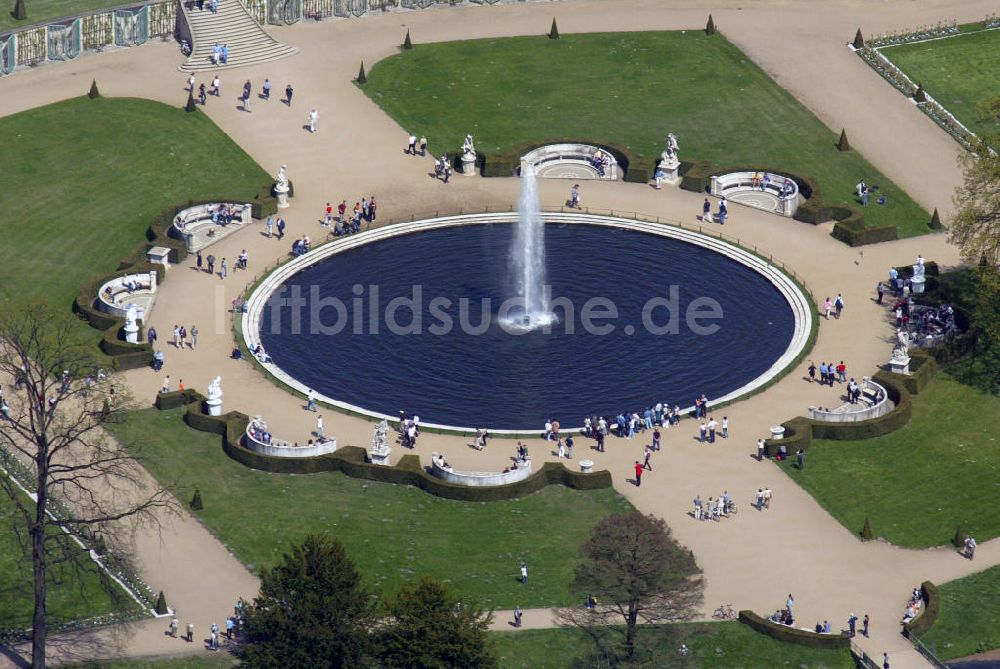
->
[557,511,704,662]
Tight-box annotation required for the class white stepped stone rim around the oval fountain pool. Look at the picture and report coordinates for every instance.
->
[242,212,815,435]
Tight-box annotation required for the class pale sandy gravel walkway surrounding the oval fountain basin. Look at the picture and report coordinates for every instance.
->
[0,0,1000,667]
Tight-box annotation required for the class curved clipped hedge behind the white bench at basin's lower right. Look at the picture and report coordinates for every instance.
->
[764,350,938,456]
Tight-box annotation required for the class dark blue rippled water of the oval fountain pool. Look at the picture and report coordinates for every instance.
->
[261,224,794,429]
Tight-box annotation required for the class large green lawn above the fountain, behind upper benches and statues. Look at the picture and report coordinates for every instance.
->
[363,30,929,236]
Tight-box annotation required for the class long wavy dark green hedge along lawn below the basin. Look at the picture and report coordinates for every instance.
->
[156,390,611,502]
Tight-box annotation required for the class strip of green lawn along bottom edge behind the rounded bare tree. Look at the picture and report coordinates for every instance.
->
[493,622,854,669]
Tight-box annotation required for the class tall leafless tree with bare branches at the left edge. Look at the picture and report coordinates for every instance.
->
[0,304,175,669]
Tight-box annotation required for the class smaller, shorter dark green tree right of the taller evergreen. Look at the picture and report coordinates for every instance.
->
[377,576,497,669]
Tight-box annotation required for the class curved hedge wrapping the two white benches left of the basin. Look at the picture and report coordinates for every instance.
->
[73,189,278,370]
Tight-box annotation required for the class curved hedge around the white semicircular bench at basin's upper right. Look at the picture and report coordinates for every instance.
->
[680,160,898,246]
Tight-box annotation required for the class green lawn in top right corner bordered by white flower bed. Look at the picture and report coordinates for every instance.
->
[882,30,1000,137]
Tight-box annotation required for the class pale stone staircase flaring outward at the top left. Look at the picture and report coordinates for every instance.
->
[178,0,298,72]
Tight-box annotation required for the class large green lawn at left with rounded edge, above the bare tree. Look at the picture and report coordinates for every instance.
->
[0,97,268,337]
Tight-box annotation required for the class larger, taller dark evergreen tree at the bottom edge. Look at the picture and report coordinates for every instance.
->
[241,534,376,669]
